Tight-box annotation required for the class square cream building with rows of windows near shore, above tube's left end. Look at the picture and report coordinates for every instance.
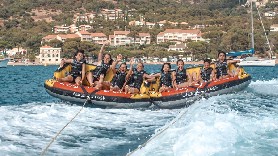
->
[38,46,62,65]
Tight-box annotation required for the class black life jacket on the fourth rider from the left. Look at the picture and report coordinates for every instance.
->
[128,69,146,89]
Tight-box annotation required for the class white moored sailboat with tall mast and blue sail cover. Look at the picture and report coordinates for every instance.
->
[227,0,275,66]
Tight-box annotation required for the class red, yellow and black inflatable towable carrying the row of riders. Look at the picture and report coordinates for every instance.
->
[44,64,251,109]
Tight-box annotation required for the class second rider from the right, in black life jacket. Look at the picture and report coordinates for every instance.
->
[199,59,215,82]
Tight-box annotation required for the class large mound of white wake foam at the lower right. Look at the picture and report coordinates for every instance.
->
[132,94,278,156]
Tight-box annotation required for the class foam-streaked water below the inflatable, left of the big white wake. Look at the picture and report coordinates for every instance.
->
[0,103,176,155]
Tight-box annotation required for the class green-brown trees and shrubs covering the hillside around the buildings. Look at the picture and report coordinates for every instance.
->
[0,0,278,59]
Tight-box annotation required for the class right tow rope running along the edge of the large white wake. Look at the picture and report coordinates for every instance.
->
[127,107,188,156]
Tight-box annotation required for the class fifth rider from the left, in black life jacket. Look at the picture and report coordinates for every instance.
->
[152,63,174,93]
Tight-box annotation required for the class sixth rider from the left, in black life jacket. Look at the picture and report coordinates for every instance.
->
[173,59,191,88]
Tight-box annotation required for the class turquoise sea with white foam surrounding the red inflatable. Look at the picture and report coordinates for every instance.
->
[0,65,278,156]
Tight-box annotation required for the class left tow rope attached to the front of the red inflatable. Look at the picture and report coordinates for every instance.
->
[41,85,91,156]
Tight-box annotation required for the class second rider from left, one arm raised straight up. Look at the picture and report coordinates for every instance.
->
[87,41,113,89]
